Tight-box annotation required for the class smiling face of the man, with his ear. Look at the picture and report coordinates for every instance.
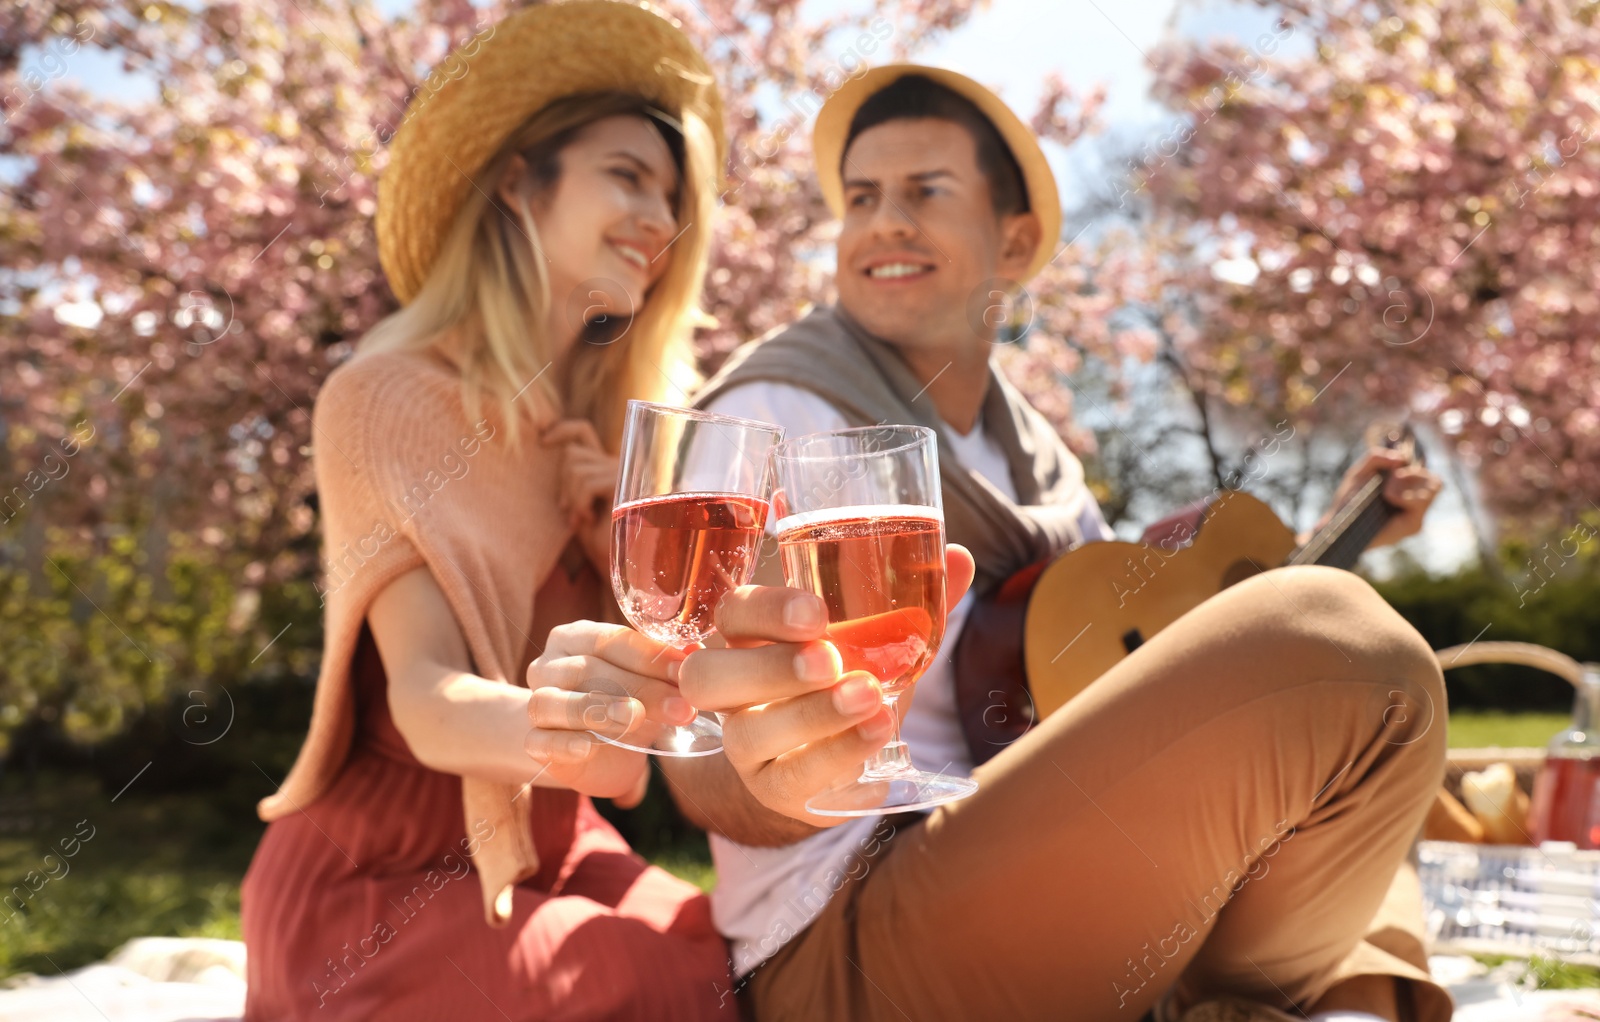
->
[837,118,1038,350]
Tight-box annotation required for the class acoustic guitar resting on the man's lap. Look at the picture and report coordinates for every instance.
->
[952,425,1424,763]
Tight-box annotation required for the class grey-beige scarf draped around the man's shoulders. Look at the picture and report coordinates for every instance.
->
[694,307,1088,593]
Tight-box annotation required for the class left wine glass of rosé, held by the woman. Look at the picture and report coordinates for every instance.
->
[590,401,784,757]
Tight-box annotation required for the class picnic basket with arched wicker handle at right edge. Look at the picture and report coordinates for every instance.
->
[1418,643,1600,966]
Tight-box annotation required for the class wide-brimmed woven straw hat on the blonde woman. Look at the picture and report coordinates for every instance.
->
[378,0,726,304]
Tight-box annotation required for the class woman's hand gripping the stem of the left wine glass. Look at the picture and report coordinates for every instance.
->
[523,621,694,809]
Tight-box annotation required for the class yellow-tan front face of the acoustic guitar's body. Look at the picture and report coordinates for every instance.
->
[1022,491,1296,718]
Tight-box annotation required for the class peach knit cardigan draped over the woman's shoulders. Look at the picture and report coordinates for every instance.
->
[258,352,578,926]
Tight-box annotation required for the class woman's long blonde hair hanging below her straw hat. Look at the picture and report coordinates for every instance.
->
[357,93,717,451]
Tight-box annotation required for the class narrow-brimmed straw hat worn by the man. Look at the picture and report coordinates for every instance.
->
[811,64,1061,283]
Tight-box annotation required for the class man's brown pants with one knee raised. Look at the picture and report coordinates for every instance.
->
[749,568,1451,1022]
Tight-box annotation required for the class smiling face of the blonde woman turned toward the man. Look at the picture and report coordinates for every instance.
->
[496,114,678,347]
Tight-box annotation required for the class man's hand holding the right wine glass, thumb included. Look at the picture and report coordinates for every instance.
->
[678,545,973,827]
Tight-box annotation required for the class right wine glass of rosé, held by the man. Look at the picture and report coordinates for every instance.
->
[773,425,978,816]
